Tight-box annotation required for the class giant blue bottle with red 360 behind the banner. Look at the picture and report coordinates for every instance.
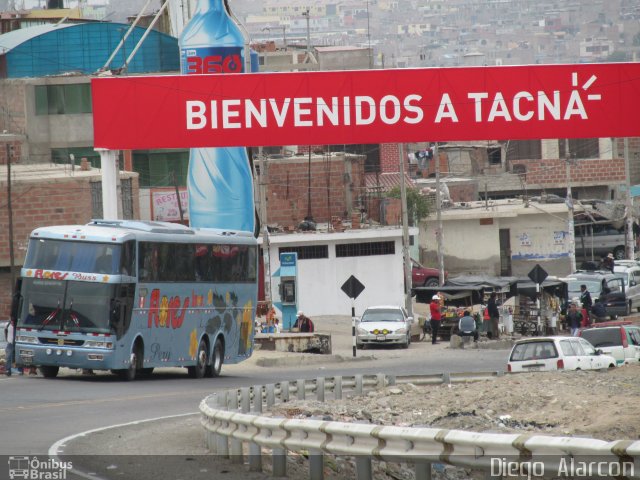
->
[179,0,255,232]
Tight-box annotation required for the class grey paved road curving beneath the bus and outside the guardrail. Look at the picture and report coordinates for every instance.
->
[0,319,507,480]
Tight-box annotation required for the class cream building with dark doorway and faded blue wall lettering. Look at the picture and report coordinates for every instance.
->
[420,199,571,276]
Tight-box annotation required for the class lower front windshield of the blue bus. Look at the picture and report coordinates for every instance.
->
[18,278,117,333]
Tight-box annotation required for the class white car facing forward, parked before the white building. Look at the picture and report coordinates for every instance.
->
[356,305,413,348]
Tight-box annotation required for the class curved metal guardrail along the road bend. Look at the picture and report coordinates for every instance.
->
[200,372,640,480]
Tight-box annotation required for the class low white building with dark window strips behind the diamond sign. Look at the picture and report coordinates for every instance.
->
[260,227,418,317]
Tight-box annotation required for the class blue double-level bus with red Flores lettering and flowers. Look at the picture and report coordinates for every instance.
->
[16,220,258,380]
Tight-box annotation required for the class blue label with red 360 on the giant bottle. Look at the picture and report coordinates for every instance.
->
[180,47,243,75]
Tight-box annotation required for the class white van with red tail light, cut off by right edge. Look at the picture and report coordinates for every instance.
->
[578,321,640,365]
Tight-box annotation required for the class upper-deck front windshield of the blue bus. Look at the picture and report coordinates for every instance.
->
[24,238,135,275]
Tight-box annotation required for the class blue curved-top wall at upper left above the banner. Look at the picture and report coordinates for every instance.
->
[6,23,180,78]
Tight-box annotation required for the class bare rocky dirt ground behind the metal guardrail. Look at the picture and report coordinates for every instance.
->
[271,365,640,440]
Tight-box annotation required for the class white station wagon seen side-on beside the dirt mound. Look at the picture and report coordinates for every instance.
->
[507,336,616,372]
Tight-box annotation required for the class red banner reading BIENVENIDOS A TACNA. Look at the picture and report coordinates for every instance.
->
[91,63,640,149]
